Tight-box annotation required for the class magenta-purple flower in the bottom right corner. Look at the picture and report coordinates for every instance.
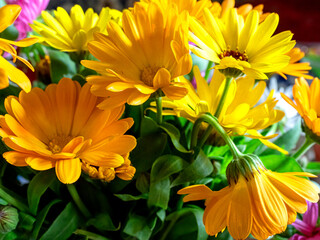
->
[290,201,320,240]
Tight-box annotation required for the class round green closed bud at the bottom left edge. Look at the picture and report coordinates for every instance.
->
[0,206,19,233]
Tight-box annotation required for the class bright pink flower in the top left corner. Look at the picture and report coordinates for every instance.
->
[5,0,50,40]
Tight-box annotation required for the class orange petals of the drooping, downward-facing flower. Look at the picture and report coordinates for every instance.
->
[178,168,319,240]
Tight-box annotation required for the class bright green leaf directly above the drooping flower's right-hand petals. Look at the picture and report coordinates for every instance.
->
[260,155,303,172]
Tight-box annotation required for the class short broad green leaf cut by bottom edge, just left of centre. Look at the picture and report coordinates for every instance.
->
[123,215,152,240]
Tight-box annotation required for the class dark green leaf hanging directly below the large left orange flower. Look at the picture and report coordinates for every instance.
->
[28,169,56,214]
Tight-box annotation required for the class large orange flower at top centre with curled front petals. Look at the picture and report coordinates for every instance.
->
[81,2,192,108]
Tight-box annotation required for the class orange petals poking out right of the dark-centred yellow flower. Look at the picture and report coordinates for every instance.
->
[277,48,313,79]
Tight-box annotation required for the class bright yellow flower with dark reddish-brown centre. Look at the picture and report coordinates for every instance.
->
[190,9,295,79]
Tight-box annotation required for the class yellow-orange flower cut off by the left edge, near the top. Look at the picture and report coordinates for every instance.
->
[0,5,37,92]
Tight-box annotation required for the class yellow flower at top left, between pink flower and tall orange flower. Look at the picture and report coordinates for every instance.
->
[31,5,122,52]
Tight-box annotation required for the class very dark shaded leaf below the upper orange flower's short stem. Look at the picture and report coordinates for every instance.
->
[130,133,167,172]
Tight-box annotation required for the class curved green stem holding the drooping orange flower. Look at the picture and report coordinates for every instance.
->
[197,113,243,160]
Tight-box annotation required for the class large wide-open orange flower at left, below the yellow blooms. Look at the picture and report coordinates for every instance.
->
[0,78,136,184]
